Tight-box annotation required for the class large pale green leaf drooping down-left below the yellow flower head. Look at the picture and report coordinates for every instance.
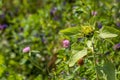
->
[68,49,87,67]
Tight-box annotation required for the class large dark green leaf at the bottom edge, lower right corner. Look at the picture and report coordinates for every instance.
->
[103,61,115,80]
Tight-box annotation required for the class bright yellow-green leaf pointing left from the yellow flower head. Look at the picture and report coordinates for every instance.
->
[60,27,80,35]
